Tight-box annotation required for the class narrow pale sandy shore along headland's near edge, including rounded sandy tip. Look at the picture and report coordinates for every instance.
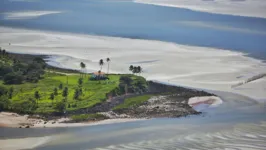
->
[0,96,220,128]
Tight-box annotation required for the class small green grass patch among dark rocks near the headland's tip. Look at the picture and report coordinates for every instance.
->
[113,95,153,110]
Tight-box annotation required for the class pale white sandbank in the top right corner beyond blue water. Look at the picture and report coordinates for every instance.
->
[133,0,266,18]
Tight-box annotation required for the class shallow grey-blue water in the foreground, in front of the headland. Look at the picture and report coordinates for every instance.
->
[0,92,266,150]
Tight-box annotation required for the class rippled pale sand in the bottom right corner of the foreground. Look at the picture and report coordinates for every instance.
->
[92,122,266,150]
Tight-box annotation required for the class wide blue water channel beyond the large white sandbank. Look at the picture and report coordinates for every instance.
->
[0,0,266,59]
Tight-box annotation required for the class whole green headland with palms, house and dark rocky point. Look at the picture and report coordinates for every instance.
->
[0,49,213,128]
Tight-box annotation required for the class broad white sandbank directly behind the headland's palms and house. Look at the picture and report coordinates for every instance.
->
[0,27,266,100]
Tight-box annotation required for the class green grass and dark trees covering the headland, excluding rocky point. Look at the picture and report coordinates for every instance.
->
[0,50,147,114]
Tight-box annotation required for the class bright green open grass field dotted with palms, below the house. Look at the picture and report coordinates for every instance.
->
[0,73,120,113]
